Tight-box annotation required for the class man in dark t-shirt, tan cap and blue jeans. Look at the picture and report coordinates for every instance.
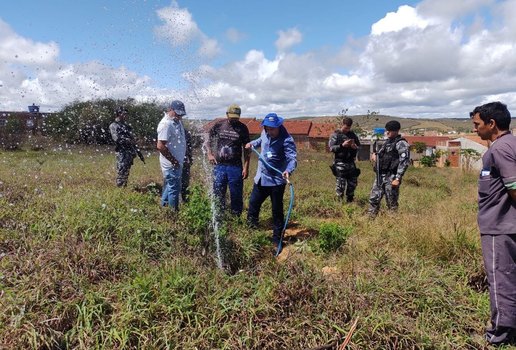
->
[207,104,250,216]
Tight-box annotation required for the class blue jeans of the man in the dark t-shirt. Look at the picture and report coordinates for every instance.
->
[213,164,244,215]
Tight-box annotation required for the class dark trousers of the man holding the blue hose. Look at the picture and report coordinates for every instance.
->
[247,182,285,243]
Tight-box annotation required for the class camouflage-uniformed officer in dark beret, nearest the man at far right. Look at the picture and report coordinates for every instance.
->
[368,120,410,218]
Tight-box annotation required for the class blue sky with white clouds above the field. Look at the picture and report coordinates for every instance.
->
[0,0,516,118]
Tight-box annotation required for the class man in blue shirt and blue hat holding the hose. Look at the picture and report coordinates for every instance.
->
[245,113,297,248]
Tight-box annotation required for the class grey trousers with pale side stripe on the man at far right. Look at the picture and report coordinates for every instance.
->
[480,234,516,344]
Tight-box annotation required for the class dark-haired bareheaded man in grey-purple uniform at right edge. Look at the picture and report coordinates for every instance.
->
[470,102,516,345]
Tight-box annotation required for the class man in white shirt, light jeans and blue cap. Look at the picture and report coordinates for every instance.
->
[156,100,186,211]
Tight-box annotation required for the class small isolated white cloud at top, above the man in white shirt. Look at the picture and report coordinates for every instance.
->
[154,1,220,58]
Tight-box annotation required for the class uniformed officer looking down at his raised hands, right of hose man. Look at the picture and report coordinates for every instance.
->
[328,117,360,203]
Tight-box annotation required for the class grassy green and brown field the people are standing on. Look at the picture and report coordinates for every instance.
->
[0,147,508,349]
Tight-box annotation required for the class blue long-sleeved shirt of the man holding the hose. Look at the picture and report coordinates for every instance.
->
[251,126,297,186]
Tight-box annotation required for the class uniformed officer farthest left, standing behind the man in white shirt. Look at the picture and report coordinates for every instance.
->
[109,106,136,187]
